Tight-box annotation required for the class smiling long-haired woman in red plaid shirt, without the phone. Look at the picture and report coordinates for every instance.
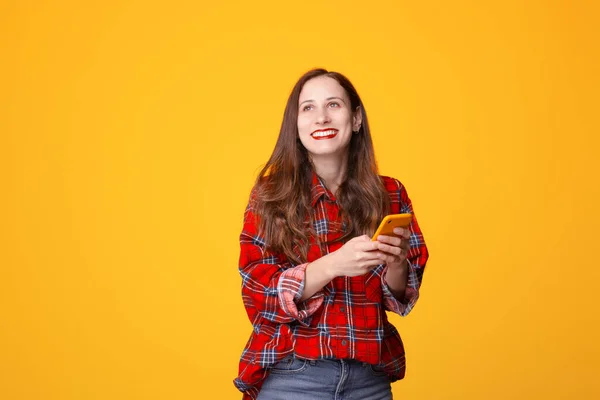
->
[234,69,428,400]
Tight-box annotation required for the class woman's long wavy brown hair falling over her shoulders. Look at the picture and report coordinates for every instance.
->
[252,69,390,263]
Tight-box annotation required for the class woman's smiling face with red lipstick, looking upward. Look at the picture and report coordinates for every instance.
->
[298,76,362,159]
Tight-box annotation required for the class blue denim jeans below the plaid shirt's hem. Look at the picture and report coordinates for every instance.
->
[258,356,392,400]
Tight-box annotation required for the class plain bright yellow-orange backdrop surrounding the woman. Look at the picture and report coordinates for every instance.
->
[0,0,600,400]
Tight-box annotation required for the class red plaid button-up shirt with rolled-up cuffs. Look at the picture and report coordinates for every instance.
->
[234,174,428,399]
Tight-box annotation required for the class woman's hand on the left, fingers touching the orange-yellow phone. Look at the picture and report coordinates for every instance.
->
[328,235,393,278]
